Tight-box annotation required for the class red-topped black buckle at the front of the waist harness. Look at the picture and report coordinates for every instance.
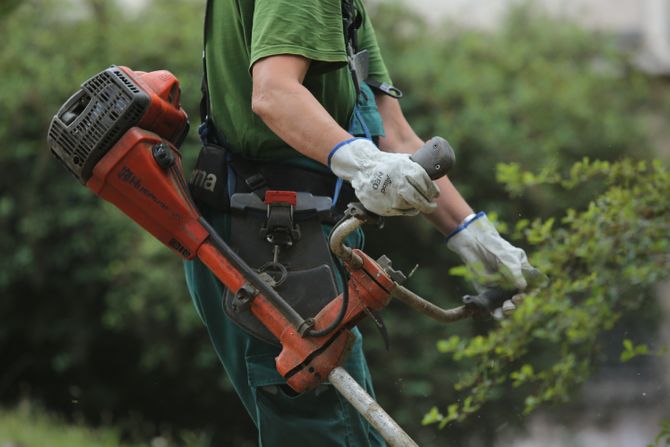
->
[261,191,300,247]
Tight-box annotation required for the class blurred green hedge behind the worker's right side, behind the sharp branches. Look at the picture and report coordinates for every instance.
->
[366,3,651,445]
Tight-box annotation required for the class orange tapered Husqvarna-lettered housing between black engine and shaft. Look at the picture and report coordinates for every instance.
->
[86,127,208,259]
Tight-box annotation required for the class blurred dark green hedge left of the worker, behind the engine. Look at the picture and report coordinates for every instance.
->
[0,0,251,444]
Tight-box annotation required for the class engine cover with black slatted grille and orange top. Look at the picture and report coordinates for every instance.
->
[47,65,189,184]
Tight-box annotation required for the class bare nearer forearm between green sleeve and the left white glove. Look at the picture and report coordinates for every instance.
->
[251,55,352,165]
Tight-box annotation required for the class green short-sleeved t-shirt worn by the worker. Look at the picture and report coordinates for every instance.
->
[205,0,391,164]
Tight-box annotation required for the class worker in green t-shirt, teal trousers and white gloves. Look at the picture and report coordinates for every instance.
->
[186,0,534,447]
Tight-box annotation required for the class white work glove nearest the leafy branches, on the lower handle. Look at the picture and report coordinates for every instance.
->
[447,212,548,318]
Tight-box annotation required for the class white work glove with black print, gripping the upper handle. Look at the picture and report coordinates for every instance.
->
[328,138,440,216]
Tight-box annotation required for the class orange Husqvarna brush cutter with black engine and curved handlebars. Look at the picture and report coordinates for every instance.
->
[48,66,509,446]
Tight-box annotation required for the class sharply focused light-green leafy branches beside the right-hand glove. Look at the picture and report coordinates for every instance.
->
[424,159,670,426]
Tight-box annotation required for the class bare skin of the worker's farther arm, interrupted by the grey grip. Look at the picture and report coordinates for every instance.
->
[375,95,472,235]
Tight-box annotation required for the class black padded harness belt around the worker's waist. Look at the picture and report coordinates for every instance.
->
[189,144,356,218]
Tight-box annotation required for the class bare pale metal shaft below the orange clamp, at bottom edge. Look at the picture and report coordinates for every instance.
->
[328,366,419,447]
